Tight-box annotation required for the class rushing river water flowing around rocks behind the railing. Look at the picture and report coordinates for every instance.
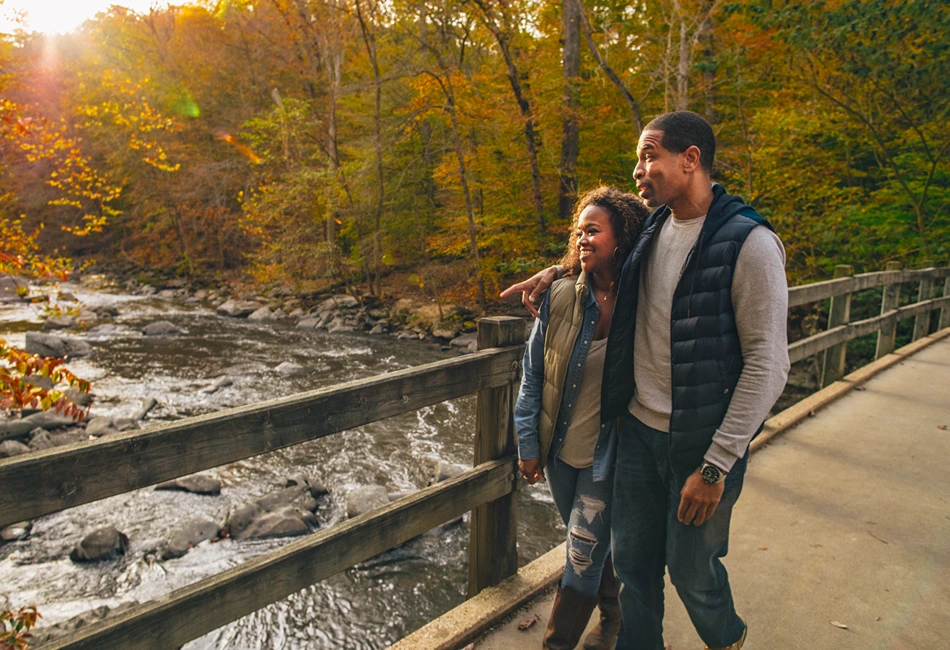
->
[0,285,564,650]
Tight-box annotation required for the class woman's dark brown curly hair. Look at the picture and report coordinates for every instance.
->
[561,185,650,275]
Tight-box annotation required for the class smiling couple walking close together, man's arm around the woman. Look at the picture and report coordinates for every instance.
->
[503,111,789,650]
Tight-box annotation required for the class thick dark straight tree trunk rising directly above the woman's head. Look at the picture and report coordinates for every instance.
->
[558,0,581,220]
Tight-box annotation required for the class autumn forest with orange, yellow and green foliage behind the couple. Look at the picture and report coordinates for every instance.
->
[0,0,950,309]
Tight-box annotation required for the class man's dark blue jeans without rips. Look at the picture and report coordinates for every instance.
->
[612,415,748,650]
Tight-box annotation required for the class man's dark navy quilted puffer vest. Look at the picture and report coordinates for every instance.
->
[601,184,772,474]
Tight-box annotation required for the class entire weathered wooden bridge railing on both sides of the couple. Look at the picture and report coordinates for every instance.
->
[0,264,950,650]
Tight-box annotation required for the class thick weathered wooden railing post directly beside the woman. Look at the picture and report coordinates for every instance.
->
[468,316,525,598]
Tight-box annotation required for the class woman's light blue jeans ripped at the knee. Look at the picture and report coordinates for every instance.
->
[545,457,614,596]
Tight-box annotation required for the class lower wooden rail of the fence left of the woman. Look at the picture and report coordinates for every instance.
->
[43,456,518,650]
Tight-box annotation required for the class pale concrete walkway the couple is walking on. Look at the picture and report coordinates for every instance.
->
[475,338,950,650]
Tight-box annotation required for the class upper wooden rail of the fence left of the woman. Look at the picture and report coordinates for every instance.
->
[0,346,523,527]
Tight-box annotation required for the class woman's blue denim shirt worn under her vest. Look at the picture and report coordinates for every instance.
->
[514,278,617,481]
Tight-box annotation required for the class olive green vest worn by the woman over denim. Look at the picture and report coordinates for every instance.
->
[538,272,588,468]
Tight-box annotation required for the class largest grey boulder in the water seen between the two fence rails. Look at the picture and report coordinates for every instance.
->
[227,477,323,541]
